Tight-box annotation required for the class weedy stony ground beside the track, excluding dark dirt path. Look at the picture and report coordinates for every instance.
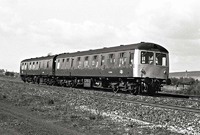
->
[0,80,200,135]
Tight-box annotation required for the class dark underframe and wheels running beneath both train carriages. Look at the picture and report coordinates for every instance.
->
[21,75,166,95]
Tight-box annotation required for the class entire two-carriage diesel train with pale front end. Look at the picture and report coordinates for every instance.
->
[20,42,170,94]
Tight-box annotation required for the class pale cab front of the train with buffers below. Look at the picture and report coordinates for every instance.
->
[133,44,170,93]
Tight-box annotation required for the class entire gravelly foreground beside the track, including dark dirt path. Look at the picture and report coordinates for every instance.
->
[0,79,200,135]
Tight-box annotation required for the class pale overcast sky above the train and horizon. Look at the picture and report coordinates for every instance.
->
[0,0,200,72]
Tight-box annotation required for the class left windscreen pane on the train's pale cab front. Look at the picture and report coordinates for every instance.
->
[141,51,154,64]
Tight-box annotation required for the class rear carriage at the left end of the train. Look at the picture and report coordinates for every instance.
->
[20,55,56,84]
